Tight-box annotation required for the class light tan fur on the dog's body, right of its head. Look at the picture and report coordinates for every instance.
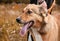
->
[40,15,58,41]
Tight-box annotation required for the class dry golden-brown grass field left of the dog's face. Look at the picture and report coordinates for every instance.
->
[0,3,60,41]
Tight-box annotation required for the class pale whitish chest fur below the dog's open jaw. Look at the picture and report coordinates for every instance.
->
[28,28,42,41]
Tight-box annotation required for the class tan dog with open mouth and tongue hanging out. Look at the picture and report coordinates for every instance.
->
[16,4,58,41]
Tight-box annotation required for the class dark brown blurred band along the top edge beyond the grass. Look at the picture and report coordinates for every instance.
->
[0,0,60,5]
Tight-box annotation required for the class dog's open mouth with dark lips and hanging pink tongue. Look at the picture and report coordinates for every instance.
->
[20,21,34,36]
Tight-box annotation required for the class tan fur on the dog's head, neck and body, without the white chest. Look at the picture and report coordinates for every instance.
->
[17,4,58,41]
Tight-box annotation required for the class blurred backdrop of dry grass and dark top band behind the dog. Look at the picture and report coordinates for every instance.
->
[0,0,60,41]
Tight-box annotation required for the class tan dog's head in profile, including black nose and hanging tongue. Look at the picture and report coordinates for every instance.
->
[16,4,48,35]
